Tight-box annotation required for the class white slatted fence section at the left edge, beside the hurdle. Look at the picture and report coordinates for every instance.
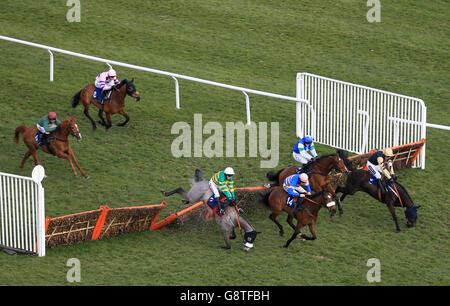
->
[0,166,45,256]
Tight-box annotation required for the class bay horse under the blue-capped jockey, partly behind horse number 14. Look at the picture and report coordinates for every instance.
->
[266,150,351,219]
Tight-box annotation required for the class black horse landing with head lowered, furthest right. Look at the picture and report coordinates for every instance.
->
[336,169,420,232]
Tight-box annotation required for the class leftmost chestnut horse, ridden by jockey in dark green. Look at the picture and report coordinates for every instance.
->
[14,118,89,179]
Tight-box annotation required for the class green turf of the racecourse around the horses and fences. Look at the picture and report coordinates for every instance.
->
[0,0,450,286]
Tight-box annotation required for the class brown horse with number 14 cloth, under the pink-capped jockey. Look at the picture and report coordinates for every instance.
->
[262,186,336,248]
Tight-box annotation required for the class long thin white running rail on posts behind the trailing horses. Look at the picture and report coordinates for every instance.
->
[0,35,309,124]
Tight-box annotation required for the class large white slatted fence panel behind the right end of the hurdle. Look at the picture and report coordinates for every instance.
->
[297,73,428,169]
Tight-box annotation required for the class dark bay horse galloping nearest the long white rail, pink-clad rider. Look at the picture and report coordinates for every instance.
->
[72,78,141,131]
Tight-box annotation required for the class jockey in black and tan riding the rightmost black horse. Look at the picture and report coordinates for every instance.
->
[366,148,395,193]
